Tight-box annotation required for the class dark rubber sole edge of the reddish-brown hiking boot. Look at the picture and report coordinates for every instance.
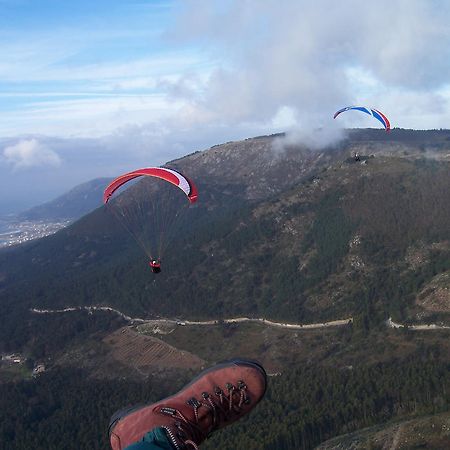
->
[108,358,267,437]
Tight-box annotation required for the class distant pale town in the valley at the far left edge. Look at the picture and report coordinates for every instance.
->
[0,220,71,248]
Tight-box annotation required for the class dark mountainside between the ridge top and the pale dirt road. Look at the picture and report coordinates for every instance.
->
[0,128,450,354]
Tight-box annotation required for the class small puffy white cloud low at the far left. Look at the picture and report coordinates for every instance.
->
[3,139,61,170]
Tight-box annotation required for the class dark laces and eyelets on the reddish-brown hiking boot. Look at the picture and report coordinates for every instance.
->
[159,380,250,450]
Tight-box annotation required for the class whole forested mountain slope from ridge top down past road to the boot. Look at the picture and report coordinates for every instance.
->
[0,130,450,450]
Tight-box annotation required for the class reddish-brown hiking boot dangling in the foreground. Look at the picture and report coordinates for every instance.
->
[109,359,267,450]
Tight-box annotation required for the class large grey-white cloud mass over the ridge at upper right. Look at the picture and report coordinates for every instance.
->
[168,0,450,141]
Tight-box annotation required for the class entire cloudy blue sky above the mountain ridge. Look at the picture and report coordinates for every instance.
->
[0,0,450,214]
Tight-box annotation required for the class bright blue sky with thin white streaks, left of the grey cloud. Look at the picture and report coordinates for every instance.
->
[0,0,205,137]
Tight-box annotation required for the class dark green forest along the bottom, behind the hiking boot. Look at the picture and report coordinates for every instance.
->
[0,354,450,450]
